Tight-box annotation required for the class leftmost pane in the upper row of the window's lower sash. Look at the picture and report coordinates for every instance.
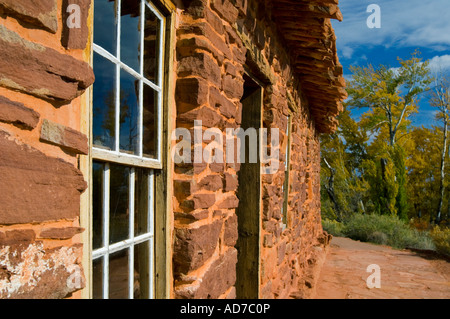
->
[92,162,104,249]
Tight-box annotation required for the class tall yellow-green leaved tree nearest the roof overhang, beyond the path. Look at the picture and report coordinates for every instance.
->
[347,51,431,219]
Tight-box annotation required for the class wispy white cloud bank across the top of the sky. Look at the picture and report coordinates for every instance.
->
[333,0,450,50]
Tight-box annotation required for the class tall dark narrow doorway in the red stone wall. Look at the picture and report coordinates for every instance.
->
[236,74,263,299]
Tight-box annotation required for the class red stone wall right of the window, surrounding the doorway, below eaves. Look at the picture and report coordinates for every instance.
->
[173,0,329,298]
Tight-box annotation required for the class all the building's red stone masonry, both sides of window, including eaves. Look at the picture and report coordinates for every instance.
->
[0,0,346,298]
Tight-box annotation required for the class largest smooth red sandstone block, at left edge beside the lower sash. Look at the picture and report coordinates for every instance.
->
[0,131,87,225]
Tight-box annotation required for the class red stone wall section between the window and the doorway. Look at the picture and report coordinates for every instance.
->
[173,0,246,298]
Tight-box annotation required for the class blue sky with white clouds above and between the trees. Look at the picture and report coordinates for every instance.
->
[332,0,450,126]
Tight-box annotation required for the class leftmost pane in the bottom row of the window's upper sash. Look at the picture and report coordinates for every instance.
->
[93,53,116,149]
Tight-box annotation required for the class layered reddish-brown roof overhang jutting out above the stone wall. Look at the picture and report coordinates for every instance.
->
[272,0,347,133]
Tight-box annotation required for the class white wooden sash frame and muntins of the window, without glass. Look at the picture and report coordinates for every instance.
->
[91,0,166,299]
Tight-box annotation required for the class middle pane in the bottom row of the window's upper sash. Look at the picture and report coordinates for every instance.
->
[120,70,139,155]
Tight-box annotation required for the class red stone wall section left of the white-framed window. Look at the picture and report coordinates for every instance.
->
[0,0,94,298]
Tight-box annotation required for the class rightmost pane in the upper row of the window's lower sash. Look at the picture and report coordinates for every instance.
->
[134,169,149,236]
